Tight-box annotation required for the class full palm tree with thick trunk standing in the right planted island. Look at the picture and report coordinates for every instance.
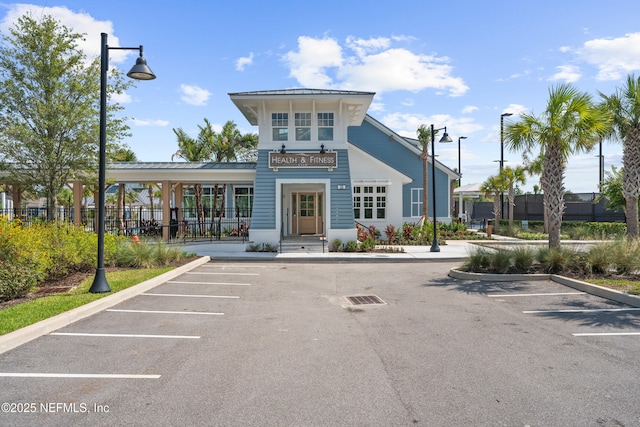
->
[505,83,609,248]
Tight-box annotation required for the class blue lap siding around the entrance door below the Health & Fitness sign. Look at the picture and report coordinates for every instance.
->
[251,150,355,230]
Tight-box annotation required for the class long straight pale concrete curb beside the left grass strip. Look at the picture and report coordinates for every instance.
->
[0,256,210,354]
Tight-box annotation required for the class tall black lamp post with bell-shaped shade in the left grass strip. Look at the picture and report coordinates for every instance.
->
[89,33,156,293]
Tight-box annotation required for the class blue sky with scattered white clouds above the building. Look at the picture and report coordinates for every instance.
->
[0,0,640,192]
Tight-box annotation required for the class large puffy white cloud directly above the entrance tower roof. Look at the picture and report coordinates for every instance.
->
[283,36,469,96]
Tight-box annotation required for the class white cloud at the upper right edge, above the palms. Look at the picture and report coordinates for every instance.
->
[577,33,640,80]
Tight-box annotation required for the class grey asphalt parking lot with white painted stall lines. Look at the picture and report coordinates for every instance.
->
[0,260,640,426]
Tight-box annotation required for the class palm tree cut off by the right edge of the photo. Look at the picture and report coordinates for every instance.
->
[600,74,640,240]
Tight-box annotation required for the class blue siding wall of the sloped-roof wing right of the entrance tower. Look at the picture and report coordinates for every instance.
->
[347,120,449,221]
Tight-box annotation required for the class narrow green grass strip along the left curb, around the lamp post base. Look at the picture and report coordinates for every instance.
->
[0,267,174,335]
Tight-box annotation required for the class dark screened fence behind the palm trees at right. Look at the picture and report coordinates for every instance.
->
[456,193,625,223]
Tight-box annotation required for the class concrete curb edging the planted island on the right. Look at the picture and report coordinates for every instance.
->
[449,268,640,307]
